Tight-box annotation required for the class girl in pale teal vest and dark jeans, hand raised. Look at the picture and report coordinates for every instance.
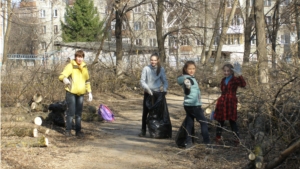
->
[177,61,210,148]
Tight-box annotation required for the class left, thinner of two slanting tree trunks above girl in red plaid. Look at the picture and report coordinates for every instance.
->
[205,0,225,64]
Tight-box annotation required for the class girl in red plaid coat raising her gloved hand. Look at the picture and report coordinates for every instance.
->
[214,62,246,144]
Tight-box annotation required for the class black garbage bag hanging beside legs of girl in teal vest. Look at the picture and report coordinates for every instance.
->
[175,118,195,147]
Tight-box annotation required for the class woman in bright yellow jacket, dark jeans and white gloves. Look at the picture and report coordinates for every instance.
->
[59,50,93,137]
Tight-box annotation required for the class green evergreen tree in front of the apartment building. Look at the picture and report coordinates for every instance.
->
[61,0,104,42]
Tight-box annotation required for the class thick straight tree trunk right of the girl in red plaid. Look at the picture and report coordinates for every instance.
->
[254,0,268,84]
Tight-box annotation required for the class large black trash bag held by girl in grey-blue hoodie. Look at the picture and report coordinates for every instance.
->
[146,92,172,138]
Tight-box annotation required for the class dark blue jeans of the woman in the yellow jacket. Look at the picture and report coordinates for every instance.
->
[66,91,83,132]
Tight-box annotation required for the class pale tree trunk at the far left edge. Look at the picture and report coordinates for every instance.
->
[2,0,12,73]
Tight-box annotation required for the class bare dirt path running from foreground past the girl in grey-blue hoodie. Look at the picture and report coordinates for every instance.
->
[47,95,219,169]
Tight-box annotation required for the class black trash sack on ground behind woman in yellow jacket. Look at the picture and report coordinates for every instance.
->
[47,101,67,127]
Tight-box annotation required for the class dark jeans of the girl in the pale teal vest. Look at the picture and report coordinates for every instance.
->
[184,106,210,144]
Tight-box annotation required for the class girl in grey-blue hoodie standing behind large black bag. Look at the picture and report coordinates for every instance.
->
[139,53,168,137]
